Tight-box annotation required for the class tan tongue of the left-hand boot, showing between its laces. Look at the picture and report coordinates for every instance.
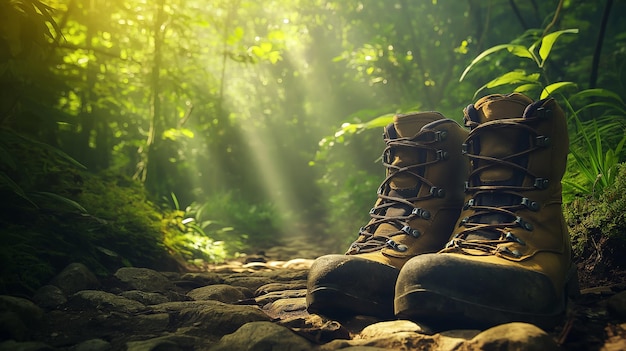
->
[374,112,444,235]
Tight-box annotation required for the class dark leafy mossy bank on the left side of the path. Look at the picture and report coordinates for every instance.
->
[0,134,171,293]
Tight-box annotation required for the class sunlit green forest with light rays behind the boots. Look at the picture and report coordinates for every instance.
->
[0,0,626,292]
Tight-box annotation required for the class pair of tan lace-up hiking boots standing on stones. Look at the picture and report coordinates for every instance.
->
[307,93,578,329]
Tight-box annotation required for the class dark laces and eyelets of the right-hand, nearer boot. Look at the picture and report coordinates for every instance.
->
[443,100,550,258]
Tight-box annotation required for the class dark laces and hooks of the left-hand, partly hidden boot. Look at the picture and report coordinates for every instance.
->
[347,130,448,254]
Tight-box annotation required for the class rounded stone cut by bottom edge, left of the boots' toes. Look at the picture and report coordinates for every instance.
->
[211,322,313,351]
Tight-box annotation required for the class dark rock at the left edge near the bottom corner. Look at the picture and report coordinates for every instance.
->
[0,295,43,341]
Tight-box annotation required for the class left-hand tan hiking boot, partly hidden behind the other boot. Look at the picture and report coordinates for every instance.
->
[307,112,467,318]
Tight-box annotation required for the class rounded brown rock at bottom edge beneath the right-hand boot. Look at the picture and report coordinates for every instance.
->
[458,322,559,351]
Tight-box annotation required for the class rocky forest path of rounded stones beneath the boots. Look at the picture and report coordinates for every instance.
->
[0,238,626,351]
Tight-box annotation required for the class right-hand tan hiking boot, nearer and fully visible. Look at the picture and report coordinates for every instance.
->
[395,94,578,328]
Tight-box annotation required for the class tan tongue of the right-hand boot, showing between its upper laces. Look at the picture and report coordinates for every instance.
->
[470,94,533,184]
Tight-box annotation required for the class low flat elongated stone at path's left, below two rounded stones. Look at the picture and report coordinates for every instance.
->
[68,290,145,313]
